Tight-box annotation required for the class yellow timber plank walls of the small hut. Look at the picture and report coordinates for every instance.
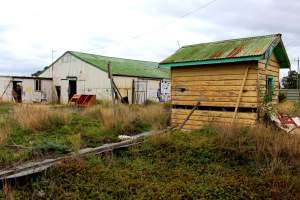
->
[171,53,279,130]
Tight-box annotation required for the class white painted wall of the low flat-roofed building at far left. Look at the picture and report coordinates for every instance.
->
[0,77,52,103]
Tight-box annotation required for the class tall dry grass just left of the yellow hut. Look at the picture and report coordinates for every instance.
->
[83,104,170,134]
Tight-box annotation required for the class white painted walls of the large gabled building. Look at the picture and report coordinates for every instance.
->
[39,53,169,103]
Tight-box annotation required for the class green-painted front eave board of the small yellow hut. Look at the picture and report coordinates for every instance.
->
[159,55,263,67]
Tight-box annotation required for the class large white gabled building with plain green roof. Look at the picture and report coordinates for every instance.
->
[33,51,170,103]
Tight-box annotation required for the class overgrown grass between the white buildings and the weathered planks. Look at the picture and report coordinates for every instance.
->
[0,103,168,168]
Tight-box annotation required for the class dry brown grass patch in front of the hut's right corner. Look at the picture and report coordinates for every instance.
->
[214,125,300,172]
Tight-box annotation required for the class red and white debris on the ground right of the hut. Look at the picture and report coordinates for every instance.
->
[271,114,300,134]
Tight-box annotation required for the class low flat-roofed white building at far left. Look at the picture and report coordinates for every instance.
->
[0,76,52,103]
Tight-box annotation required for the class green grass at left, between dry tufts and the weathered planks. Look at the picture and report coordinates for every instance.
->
[0,113,118,167]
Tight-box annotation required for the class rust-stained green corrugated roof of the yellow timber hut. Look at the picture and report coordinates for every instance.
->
[160,34,290,67]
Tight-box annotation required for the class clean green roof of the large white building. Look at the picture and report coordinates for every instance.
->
[69,51,170,78]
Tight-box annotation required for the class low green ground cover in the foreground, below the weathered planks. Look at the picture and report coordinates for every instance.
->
[6,128,300,200]
